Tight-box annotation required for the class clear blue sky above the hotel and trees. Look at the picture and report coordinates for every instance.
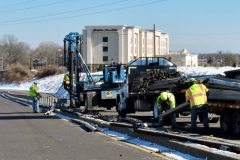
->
[0,0,240,53]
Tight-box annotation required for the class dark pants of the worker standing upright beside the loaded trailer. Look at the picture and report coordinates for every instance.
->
[191,104,209,130]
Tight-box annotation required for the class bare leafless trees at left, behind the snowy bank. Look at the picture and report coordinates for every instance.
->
[0,35,63,70]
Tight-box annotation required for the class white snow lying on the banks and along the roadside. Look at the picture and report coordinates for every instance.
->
[0,67,240,160]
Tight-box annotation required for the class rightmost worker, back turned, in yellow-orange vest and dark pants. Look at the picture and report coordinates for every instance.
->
[185,78,210,134]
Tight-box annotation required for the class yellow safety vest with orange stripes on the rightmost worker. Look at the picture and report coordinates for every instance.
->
[185,84,208,108]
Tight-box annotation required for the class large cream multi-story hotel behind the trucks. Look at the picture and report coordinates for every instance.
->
[82,25,169,64]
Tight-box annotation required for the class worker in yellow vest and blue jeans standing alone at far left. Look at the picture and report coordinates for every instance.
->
[29,82,40,113]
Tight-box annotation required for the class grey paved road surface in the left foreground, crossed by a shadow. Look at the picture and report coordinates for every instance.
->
[0,97,164,160]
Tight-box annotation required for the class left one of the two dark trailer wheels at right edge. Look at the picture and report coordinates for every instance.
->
[220,109,232,134]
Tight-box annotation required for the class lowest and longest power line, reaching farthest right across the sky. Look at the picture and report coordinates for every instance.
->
[1,0,167,25]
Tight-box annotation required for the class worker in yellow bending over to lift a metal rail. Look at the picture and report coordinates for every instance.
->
[157,92,176,128]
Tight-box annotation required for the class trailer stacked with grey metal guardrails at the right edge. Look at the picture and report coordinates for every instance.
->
[165,70,240,136]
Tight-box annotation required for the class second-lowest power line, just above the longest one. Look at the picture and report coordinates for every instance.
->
[0,0,128,23]
